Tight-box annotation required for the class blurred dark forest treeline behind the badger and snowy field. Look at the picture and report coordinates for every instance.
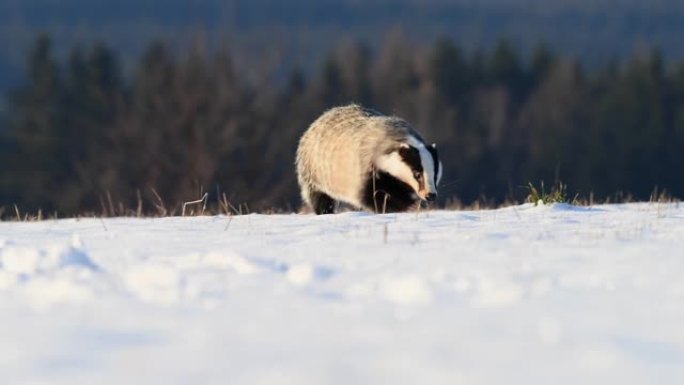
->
[0,31,684,217]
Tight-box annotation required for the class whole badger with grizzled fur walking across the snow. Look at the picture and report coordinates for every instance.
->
[295,104,442,214]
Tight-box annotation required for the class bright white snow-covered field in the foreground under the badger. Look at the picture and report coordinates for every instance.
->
[0,203,684,385]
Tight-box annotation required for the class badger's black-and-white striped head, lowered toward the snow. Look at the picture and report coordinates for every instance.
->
[376,136,442,202]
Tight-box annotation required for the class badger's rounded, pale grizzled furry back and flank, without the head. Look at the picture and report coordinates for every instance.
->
[296,105,413,207]
